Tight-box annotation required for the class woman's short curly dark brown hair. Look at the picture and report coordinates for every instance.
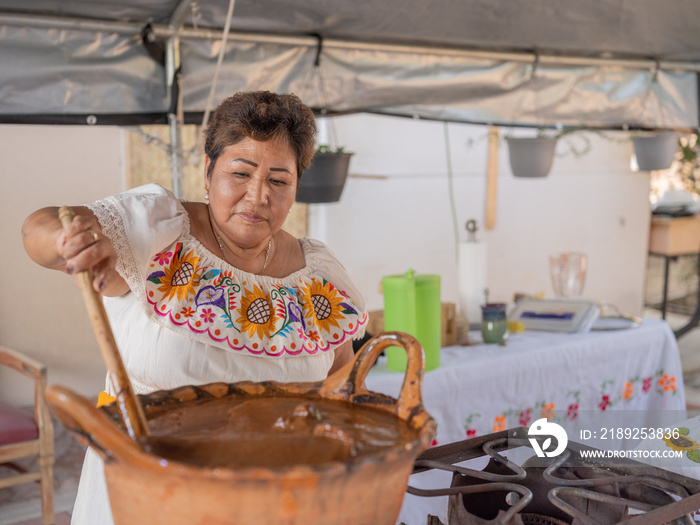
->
[204,91,316,178]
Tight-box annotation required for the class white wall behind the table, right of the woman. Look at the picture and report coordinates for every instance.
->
[309,115,650,314]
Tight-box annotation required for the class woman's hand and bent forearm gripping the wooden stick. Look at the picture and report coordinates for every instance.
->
[22,206,129,296]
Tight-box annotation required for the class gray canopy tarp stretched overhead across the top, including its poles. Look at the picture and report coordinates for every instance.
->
[0,0,700,130]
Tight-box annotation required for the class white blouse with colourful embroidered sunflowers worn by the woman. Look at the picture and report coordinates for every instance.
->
[89,184,367,394]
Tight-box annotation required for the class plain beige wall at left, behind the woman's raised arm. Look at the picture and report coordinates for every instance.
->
[0,125,124,405]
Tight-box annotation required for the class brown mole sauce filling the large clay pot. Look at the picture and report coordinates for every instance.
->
[141,396,412,468]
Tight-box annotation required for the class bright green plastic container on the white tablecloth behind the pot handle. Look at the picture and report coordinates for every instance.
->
[382,270,442,372]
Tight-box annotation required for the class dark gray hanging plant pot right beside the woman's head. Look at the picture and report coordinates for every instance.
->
[296,152,352,203]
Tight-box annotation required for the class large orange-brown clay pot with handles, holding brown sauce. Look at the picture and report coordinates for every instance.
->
[47,332,436,525]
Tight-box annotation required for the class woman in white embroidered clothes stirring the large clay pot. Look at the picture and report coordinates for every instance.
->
[23,92,367,525]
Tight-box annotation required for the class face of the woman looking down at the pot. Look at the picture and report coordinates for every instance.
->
[204,138,297,248]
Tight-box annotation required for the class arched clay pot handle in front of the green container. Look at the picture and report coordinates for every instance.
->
[321,332,425,420]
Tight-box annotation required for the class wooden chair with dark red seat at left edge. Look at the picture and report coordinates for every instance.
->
[0,347,54,525]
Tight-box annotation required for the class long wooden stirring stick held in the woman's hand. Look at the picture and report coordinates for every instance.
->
[58,206,148,439]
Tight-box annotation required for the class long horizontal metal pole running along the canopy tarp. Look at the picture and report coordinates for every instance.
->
[0,10,700,73]
